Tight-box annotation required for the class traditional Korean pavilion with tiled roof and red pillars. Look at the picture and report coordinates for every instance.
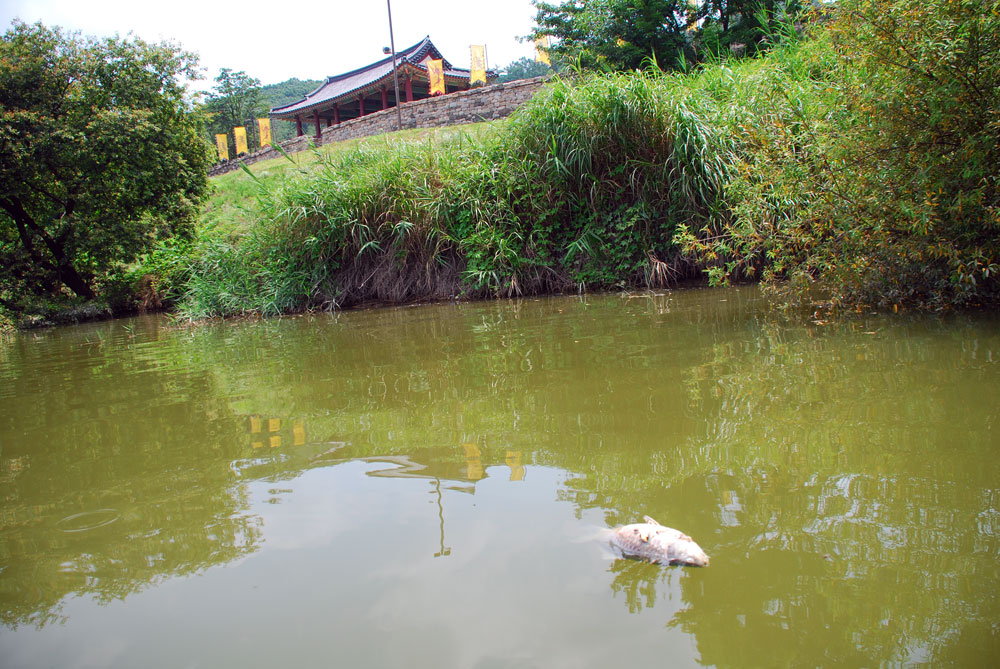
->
[270,37,497,136]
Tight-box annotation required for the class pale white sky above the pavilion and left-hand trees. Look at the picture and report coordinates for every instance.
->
[0,0,535,89]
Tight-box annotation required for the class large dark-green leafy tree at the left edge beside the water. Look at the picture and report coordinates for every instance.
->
[0,20,208,308]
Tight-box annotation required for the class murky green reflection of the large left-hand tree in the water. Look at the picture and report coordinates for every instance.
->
[0,316,260,628]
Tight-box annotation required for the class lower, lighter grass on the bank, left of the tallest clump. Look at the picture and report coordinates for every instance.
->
[186,137,461,316]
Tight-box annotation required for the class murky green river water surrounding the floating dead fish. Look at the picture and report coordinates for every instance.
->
[0,289,1000,667]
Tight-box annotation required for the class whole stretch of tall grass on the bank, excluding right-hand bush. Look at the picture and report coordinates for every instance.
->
[184,62,752,316]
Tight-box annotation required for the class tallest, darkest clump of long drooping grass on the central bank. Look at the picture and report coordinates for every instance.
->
[450,72,728,293]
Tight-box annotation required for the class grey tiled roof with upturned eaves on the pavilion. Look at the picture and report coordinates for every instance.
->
[271,36,495,118]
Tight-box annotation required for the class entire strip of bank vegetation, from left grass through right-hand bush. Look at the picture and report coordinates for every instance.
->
[3,0,1000,328]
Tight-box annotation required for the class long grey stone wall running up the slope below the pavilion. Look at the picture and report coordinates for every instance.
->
[208,77,547,177]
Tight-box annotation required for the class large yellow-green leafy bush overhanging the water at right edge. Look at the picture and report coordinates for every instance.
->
[688,0,1000,306]
